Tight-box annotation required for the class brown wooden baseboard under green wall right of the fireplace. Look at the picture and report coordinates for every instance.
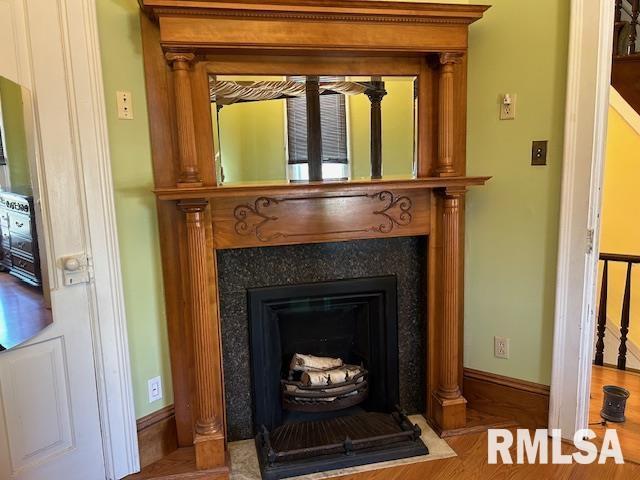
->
[463,368,549,428]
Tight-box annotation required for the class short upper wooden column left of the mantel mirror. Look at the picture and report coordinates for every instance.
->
[166,52,202,187]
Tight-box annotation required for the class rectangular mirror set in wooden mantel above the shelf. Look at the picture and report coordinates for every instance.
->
[210,76,417,184]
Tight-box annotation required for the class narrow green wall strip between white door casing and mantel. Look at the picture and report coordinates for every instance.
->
[97,0,173,418]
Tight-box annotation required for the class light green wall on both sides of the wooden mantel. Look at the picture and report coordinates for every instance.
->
[97,0,569,417]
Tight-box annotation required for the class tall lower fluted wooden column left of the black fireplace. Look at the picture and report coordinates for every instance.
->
[178,200,225,469]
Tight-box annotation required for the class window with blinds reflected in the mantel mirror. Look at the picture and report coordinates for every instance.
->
[286,77,350,182]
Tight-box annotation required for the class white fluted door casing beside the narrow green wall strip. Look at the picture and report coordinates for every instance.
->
[59,0,140,479]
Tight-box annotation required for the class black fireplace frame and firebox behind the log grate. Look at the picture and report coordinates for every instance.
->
[249,276,399,430]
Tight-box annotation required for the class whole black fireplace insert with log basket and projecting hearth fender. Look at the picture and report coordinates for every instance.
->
[248,276,427,480]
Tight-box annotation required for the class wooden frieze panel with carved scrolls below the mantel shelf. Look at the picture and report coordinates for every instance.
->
[213,190,430,249]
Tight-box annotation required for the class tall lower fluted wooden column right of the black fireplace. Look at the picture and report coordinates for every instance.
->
[435,188,467,430]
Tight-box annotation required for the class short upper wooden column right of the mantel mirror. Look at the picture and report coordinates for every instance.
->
[436,53,462,177]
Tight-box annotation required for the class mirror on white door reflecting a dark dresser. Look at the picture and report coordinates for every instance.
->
[0,77,53,350]
